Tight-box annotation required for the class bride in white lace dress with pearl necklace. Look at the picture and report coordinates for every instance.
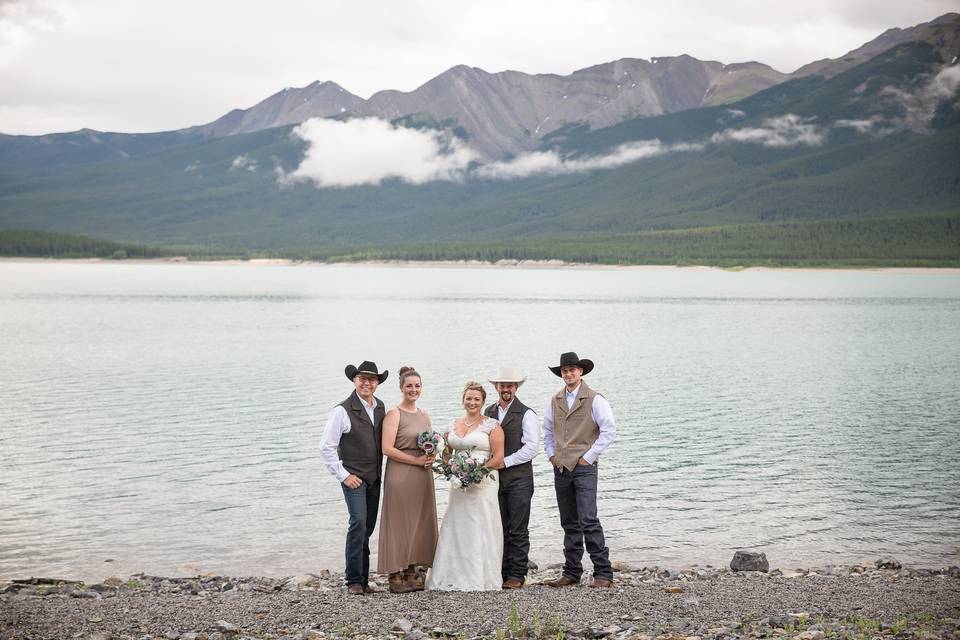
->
[426,381,503,591]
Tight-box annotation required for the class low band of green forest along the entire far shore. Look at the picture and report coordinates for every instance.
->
[0,211,960,267]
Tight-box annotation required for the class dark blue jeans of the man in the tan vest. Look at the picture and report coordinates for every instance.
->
[553,464,613,581]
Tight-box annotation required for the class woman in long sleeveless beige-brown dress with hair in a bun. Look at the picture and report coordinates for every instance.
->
[377,367,438,593]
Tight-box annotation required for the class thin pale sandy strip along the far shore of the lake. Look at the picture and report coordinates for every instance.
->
[0,256,960,275]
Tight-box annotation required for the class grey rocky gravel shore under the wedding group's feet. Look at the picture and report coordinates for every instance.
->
[0,559,960,640]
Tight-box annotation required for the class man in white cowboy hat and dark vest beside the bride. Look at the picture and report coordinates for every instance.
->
[484,367,540,589]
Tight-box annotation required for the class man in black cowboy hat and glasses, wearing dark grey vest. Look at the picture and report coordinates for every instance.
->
[320,360,389,595]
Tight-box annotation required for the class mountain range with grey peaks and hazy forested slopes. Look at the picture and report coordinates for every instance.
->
[0,14,960,257]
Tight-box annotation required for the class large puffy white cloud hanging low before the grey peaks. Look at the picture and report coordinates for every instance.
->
[278,118,477,187]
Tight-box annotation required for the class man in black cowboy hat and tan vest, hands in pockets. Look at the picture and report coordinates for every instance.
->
[543,351,614,587]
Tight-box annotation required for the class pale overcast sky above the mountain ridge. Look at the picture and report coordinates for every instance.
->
[0,0,960,134]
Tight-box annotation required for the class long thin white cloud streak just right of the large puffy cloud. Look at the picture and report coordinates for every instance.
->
[474,140,703,180]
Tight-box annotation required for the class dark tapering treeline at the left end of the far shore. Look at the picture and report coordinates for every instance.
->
[0,229,174,259]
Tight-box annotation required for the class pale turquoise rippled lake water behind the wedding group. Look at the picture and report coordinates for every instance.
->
[0,262,960,579]
